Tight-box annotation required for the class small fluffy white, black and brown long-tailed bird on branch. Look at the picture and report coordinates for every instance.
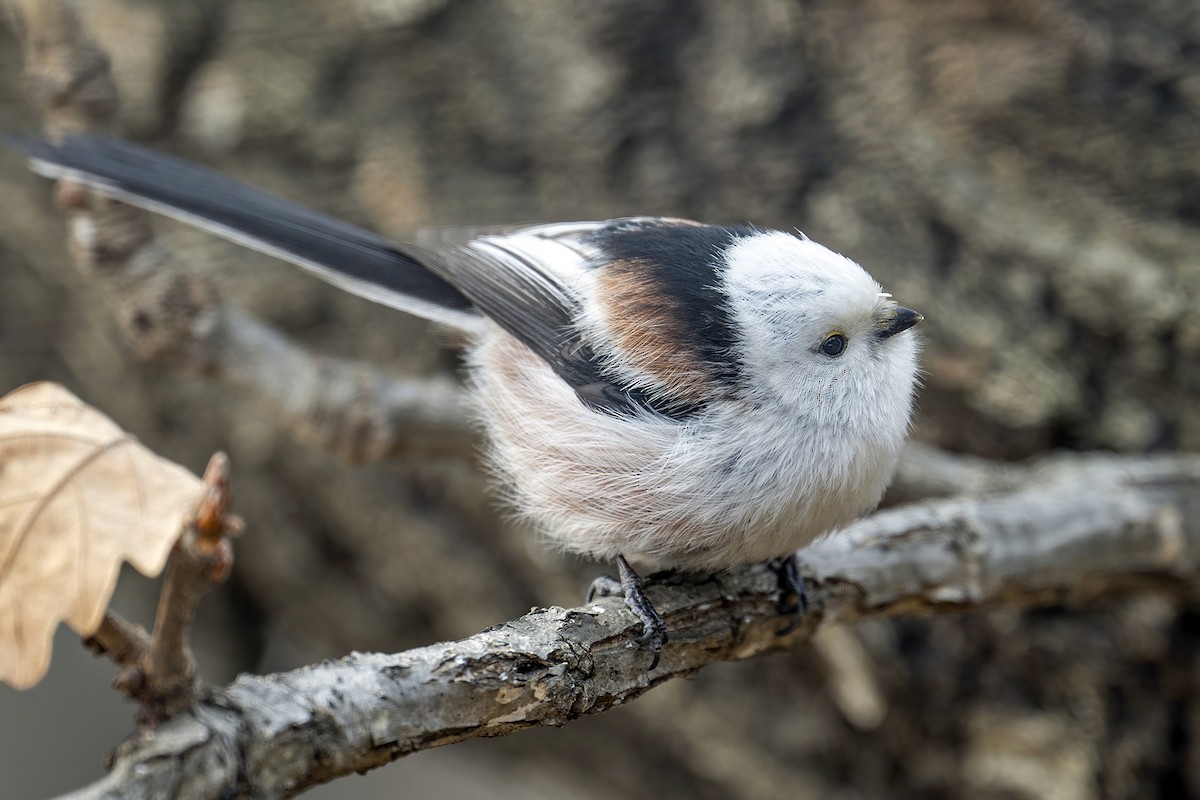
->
[10,133,923,669]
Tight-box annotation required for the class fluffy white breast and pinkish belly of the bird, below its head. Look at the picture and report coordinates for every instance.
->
[472,321,916,570]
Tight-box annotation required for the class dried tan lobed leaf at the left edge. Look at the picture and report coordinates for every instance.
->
[0,383,204,688]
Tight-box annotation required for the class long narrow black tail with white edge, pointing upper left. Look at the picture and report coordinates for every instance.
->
[8,136,480,329]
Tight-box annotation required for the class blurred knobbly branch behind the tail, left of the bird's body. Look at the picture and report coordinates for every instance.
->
[11,0,473,462]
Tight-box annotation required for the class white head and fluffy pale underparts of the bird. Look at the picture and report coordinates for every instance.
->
[470,231,918,570]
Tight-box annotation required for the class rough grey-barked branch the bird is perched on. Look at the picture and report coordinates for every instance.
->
[60,456,1200,799]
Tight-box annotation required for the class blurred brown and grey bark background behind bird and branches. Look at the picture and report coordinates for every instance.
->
[0,0,1200,800]
